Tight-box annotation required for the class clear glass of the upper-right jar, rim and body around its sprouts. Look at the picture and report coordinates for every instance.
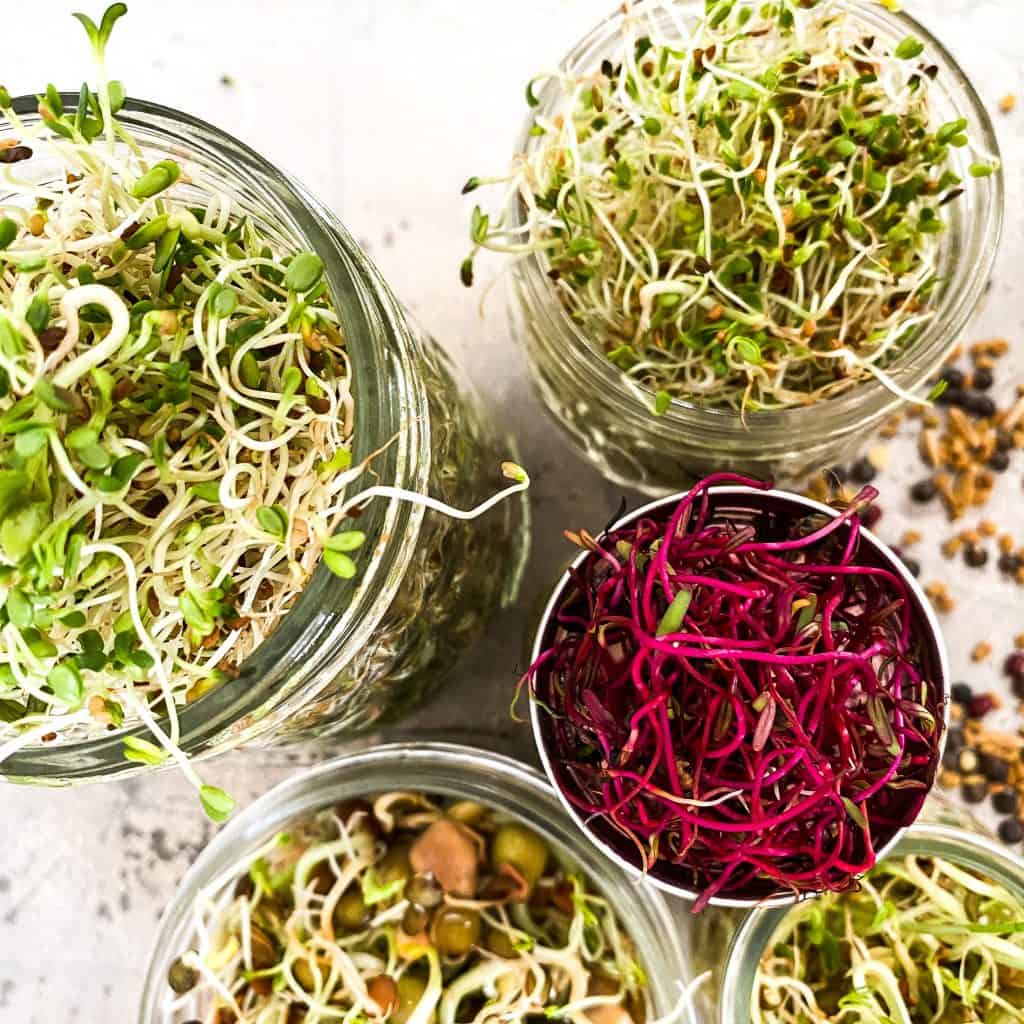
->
[509,0,1004,495]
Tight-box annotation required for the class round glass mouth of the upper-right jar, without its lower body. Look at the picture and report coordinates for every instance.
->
[509,0,1005,436]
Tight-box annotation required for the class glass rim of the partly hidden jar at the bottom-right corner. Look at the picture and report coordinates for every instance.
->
[719,822,1024,1024]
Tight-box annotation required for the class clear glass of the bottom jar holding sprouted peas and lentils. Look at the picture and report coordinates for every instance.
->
[138,742,687,1024]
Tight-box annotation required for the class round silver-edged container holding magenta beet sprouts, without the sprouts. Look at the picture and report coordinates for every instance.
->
[527,484,950,909]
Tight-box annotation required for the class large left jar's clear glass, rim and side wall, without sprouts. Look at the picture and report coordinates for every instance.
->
[0,93,528,784]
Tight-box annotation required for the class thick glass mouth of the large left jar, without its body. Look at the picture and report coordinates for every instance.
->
[0,92,430,784]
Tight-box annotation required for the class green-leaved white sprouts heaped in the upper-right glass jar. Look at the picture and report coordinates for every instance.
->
[462,0,997,414]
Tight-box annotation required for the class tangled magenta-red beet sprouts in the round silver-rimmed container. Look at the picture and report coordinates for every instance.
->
[526,473,942,910]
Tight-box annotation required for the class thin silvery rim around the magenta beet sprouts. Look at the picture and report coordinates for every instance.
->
[529,484,950,909]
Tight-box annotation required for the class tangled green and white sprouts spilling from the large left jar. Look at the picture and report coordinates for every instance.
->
[0,4,528,820]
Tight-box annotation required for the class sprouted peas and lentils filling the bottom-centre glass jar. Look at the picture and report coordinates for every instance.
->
[162,793,650,1024]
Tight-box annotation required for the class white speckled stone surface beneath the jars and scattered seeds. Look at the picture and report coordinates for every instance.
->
[0,0,1024,1024]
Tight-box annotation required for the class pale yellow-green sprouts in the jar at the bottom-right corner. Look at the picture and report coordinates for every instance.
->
[751,856,1024,1024]
